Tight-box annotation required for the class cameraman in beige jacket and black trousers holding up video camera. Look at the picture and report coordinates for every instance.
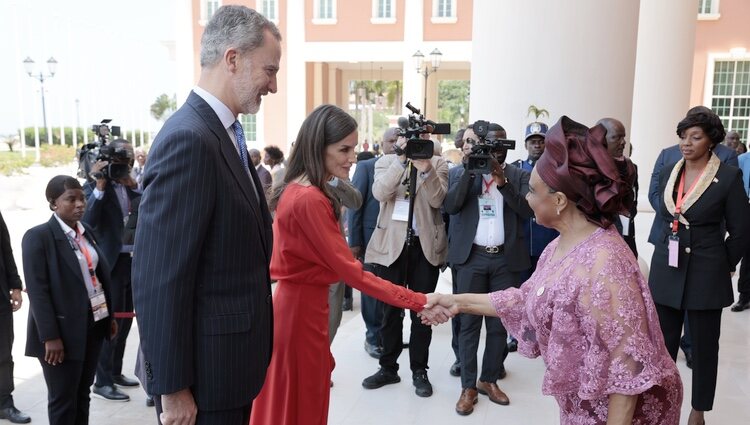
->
[362,119,448,397]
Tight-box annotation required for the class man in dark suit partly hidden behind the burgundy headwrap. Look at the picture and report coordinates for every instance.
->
[596,118,638,255]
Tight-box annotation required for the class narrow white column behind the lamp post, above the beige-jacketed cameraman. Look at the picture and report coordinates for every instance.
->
[399,0,432,115]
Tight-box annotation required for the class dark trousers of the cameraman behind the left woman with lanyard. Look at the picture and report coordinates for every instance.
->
[96,254,133,387]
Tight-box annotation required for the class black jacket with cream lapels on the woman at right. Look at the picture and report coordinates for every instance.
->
[648,159,750,310]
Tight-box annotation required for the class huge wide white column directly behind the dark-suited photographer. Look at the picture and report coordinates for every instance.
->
[469,0,639,161]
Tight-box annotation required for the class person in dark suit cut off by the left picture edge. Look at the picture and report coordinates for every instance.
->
[0,210,31,424]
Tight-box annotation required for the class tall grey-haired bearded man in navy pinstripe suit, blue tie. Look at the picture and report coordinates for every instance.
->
[133,5,281,425]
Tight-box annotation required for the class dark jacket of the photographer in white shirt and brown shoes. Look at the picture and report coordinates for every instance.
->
[443,164,534,272]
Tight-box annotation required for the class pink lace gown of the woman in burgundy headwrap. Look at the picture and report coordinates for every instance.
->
[490,226,682,425]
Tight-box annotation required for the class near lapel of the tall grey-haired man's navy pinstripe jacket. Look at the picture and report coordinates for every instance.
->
[187,92,269,255]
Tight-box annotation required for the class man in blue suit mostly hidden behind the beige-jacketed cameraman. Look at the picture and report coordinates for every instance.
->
[347,127,398,359]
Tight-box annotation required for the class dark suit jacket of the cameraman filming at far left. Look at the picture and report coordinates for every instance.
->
[81,182,141,272]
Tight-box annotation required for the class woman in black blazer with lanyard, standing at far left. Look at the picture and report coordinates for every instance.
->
[22,176,116,425]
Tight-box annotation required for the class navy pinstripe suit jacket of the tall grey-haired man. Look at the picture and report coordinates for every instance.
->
[133,93,273,410]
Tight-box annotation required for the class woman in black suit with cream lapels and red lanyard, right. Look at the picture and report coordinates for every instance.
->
[649,111,750,425]
